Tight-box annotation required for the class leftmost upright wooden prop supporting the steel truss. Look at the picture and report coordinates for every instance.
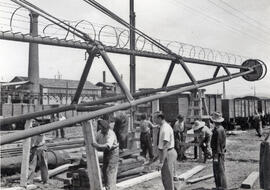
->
[20,119,32,187]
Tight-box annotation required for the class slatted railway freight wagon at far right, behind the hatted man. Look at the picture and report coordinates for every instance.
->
[222,96,270,129]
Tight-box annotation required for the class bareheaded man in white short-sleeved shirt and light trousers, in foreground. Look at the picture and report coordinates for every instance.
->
[157,114,177,190]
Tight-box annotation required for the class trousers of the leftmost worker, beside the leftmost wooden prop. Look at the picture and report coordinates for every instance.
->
[28,146,49,183]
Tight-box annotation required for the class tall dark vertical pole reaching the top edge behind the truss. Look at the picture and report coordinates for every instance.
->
[129,0,136,93]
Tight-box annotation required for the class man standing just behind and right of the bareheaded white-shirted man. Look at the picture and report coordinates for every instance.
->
[173,115,187,161]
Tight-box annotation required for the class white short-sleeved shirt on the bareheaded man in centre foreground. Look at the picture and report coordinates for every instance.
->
[158,121,174,149]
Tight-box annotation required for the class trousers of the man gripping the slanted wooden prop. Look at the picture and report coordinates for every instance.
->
[102,148,119,190]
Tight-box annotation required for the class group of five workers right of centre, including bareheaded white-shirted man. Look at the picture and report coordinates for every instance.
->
[140,112,227,190]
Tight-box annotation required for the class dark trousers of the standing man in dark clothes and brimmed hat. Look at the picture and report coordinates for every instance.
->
[213,154,227,189]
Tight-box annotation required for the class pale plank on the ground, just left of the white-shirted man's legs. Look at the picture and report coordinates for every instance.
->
[116,171,160,189]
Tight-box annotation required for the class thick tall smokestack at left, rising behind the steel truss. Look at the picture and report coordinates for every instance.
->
[28,12,40,104]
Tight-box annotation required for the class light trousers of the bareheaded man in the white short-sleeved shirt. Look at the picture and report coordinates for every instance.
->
[161,148,177,190]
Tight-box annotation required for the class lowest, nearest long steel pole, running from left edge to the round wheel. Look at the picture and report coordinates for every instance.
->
[0,70,253,145]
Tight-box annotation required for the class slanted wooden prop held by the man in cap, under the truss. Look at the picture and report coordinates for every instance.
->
[82,121,102,190]
